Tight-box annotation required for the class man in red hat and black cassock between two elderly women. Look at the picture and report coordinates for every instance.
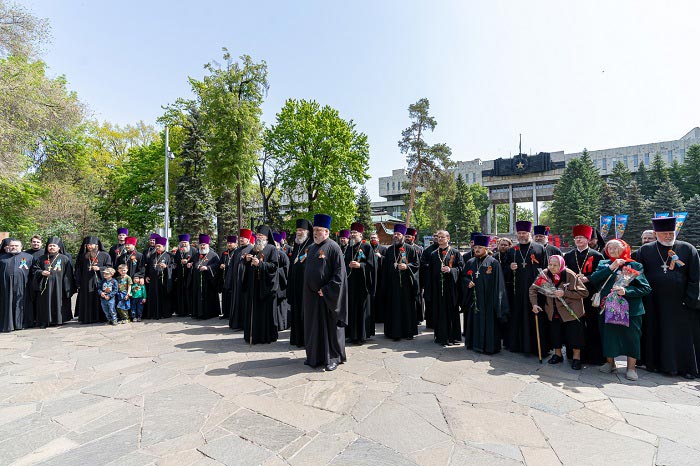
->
[564,225,605,366]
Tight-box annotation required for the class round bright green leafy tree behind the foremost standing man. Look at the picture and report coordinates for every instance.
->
[267,99,369,229]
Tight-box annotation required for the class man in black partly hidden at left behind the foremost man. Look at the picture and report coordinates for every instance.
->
[287,218,314,348]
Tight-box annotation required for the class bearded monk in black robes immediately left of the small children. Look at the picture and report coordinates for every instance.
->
[75,236,112,324]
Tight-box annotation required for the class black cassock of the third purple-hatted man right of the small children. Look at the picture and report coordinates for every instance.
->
[190,250,221,319]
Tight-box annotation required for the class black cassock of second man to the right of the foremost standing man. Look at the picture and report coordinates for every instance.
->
[381,245,420,339]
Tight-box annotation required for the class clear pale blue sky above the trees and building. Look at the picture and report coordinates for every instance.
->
[19,0,700,199]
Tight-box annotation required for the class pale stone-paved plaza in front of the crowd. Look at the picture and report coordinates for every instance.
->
[0,319,700,466]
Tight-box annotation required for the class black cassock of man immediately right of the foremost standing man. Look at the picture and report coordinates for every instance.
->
[345,243,377,342]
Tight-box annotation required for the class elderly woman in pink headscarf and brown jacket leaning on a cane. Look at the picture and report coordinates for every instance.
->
[530,254,588,371]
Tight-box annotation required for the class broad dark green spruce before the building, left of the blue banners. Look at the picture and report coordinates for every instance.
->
[551,149,602,233]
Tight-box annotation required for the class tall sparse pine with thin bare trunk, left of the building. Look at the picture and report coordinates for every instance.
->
[399,98,454,226]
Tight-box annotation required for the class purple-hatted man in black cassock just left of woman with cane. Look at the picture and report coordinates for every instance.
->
[508,221,550,356]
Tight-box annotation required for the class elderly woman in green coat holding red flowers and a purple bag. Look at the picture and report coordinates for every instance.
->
[590,239,651,381]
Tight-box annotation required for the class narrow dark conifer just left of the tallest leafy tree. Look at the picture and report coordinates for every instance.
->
[173,106,215,235]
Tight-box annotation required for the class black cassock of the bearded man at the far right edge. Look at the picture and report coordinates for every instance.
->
[637,241,700,377]
